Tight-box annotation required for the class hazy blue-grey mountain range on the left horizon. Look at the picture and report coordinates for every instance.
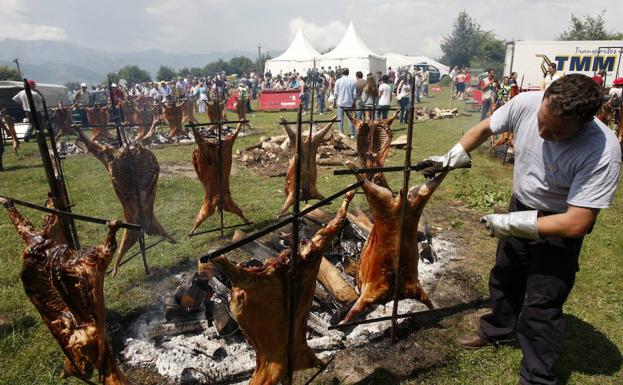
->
[0,39,280,84]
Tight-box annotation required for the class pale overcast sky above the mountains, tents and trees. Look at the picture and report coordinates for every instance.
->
[0,0,623,57]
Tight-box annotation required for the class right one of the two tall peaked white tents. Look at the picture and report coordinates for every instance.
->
[317,21,385,77]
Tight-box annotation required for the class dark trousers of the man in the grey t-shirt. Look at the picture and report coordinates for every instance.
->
[478,197,583,385]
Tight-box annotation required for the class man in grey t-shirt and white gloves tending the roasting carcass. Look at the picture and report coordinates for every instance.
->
[416,74,621,385]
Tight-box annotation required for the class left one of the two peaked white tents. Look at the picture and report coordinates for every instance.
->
[265,29,321,75]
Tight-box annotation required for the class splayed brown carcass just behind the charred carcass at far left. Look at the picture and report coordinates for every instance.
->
[78,130,175,274]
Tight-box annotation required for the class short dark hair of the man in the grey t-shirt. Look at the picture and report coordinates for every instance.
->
[544,74,603,123]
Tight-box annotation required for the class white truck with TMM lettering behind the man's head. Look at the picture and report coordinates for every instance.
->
[504,40,623,89]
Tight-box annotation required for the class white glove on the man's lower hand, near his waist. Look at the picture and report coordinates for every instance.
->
[480,210,540,240]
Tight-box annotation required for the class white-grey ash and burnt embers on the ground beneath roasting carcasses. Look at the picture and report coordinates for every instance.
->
[121,238,456,385]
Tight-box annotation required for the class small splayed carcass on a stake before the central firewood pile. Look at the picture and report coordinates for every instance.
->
[279,116,337,215]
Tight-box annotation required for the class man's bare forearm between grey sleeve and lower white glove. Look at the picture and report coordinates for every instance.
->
[537,205,599,238]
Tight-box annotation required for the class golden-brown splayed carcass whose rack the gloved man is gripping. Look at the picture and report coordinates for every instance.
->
[342,166,446,322]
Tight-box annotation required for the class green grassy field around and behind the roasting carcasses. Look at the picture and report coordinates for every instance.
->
[0,92,623,385]
